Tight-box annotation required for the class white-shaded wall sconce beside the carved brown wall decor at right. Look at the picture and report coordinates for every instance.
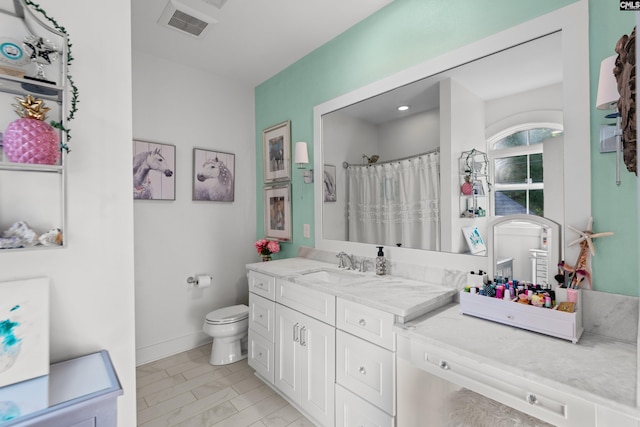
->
[596,55,622,185]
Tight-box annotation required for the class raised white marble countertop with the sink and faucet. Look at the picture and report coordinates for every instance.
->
[246,258,457,323]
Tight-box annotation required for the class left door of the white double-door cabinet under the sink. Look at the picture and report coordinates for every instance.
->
[274,304,304,402]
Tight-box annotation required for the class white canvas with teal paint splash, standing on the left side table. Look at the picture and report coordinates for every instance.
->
[0,277,49,387]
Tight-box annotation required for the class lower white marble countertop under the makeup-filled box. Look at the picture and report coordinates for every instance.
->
[395,304,638,416]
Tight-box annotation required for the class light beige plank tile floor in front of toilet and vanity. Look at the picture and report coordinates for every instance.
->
[136,344,314,427]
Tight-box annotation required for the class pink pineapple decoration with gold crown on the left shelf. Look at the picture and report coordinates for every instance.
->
[4,95,60,165]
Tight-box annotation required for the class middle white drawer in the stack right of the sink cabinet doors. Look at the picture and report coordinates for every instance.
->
[336,330,396,415]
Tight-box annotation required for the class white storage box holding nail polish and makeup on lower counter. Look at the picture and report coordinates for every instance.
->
[460,288,584,344]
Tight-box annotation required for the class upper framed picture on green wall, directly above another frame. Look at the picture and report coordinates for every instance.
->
[262,120,291,182]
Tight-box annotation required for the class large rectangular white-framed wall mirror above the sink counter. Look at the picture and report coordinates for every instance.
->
[314,1,591,269]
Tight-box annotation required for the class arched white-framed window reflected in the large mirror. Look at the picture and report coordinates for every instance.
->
[488,123,562,216]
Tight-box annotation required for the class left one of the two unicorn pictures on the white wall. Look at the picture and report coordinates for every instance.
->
[133,140,176,200]
